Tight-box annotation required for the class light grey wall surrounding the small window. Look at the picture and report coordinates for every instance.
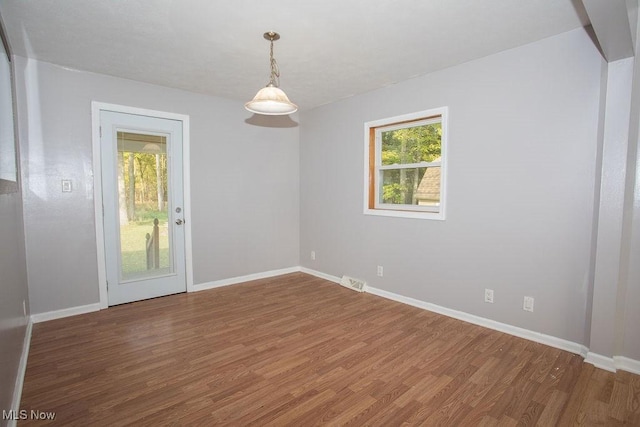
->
[300,29,603,343]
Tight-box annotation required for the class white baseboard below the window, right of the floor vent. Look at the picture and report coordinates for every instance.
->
[367,287,587,357]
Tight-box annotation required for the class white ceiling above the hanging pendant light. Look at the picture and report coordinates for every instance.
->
[0,0,589,109]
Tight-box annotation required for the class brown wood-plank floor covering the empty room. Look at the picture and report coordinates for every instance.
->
[19,273,640,426]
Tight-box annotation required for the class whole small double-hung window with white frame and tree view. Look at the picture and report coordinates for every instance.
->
[364,107,447,219]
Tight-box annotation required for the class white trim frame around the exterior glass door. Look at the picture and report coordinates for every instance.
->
[91,101,194,309]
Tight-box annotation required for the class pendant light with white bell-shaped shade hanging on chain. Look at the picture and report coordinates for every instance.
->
[244,31,298,116]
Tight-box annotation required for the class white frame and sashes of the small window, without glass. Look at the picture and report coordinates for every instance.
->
[364,107,449,220]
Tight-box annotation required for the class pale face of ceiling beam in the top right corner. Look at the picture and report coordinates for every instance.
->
[582,0,635,62]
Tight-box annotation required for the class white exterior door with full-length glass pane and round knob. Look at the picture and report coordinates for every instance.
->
[100,111,186,305]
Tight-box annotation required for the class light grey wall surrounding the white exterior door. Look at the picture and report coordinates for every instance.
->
[16,58,299,313]
